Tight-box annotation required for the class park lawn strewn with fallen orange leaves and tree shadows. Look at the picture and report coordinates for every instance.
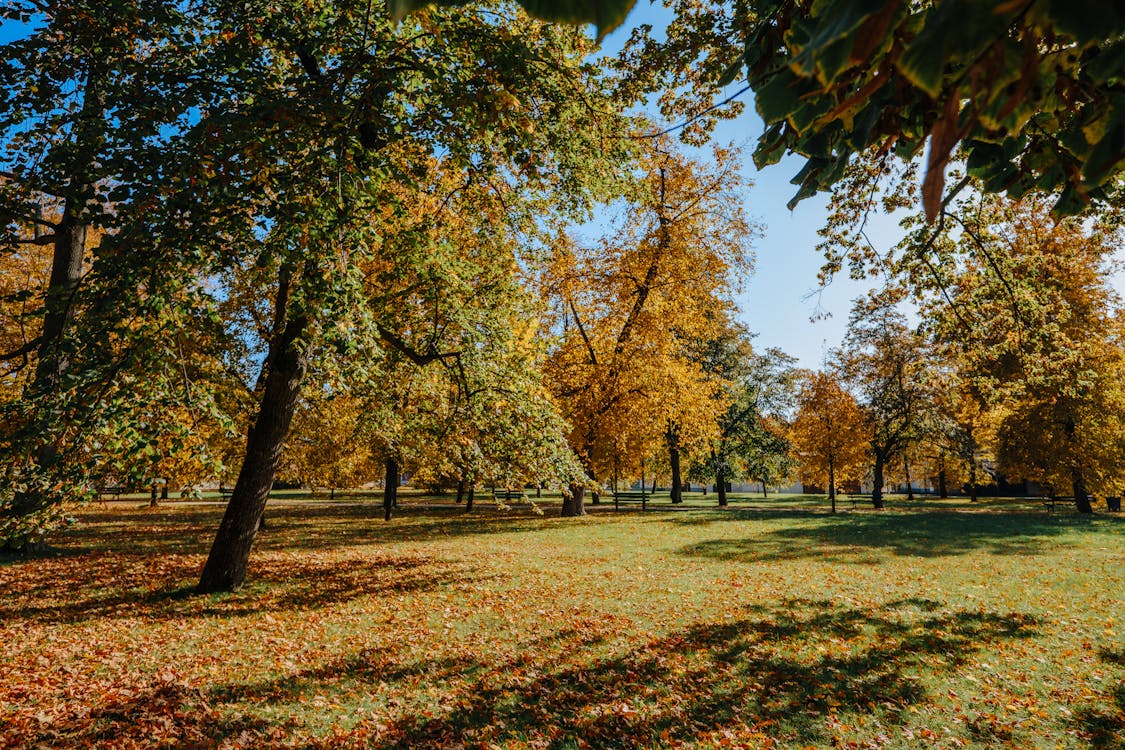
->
[0,495,1125,749]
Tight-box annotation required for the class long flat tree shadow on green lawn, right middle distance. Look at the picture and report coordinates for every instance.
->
[681,512,1091,563]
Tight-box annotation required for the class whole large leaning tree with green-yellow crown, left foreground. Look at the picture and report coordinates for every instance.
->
[182,2,617,591]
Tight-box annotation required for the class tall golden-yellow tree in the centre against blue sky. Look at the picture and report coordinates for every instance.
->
[546,141,753,515]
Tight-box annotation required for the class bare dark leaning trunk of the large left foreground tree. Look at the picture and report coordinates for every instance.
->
[196,316,308,594]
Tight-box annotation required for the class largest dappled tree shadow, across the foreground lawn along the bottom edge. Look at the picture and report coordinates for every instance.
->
[10,599,1071,749]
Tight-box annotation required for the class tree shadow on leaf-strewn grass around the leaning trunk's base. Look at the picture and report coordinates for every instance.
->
[0,553,479,623]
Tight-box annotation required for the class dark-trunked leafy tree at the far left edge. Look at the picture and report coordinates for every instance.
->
[0,0,209,549]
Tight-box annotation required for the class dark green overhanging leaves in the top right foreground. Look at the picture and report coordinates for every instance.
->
[621,0,1125,222]
